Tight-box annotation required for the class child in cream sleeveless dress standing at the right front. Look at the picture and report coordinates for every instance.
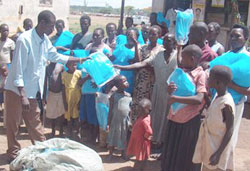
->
[193,66,235,171]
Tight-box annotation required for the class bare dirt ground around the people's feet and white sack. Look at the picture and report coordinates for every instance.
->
[0,106,250,171]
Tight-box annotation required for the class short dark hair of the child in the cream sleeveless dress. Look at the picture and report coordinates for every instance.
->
[210,65,233,85]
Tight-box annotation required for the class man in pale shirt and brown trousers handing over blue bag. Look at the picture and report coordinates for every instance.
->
[5,10,86,161]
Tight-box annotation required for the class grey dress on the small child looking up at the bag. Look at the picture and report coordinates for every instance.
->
[107,93,132,150]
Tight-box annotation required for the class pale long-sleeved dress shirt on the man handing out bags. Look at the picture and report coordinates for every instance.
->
[5,29,69,99]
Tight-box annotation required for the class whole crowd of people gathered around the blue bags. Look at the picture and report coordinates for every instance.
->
[0,7,250,171]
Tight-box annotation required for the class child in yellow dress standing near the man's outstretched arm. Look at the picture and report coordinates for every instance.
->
[62,62,81,138]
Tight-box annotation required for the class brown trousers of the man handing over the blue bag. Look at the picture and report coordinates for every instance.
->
[5,90,46,158]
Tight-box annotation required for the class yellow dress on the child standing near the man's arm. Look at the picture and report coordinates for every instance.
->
[62,70,81,121]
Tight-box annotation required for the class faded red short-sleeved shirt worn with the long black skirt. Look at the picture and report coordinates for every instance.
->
[168,67,207,123]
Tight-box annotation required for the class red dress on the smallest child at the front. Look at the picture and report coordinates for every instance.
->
[127,115,153,161]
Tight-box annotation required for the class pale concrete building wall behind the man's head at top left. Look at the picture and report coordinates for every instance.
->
[0,0,70,33]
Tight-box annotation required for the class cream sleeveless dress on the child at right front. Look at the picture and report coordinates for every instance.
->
[193,93,235,170]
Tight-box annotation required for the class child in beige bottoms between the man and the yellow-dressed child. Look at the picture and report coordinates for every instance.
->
[46,63,65,137]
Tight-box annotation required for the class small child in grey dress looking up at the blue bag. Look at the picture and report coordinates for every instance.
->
[107,75,132,159]
